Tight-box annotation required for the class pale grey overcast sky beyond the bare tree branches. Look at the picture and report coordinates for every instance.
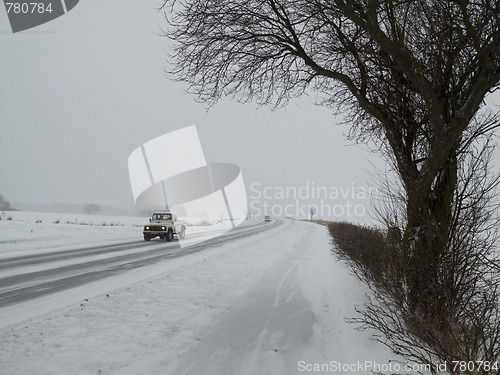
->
[0,0,500,222]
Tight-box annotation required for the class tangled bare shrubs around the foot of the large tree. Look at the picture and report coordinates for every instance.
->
[354,118,500,374]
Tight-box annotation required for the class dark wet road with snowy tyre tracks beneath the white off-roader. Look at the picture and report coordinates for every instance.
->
[0,221,281,308]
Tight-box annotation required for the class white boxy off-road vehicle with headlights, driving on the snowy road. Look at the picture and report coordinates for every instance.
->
[143,212,186,242]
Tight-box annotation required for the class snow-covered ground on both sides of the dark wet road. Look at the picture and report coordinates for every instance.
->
[0,214,426,375]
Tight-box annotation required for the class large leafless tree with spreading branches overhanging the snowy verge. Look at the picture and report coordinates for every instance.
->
[163,0,500,370]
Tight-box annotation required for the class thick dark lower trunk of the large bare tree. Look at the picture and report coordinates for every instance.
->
[403,149,457,321]
